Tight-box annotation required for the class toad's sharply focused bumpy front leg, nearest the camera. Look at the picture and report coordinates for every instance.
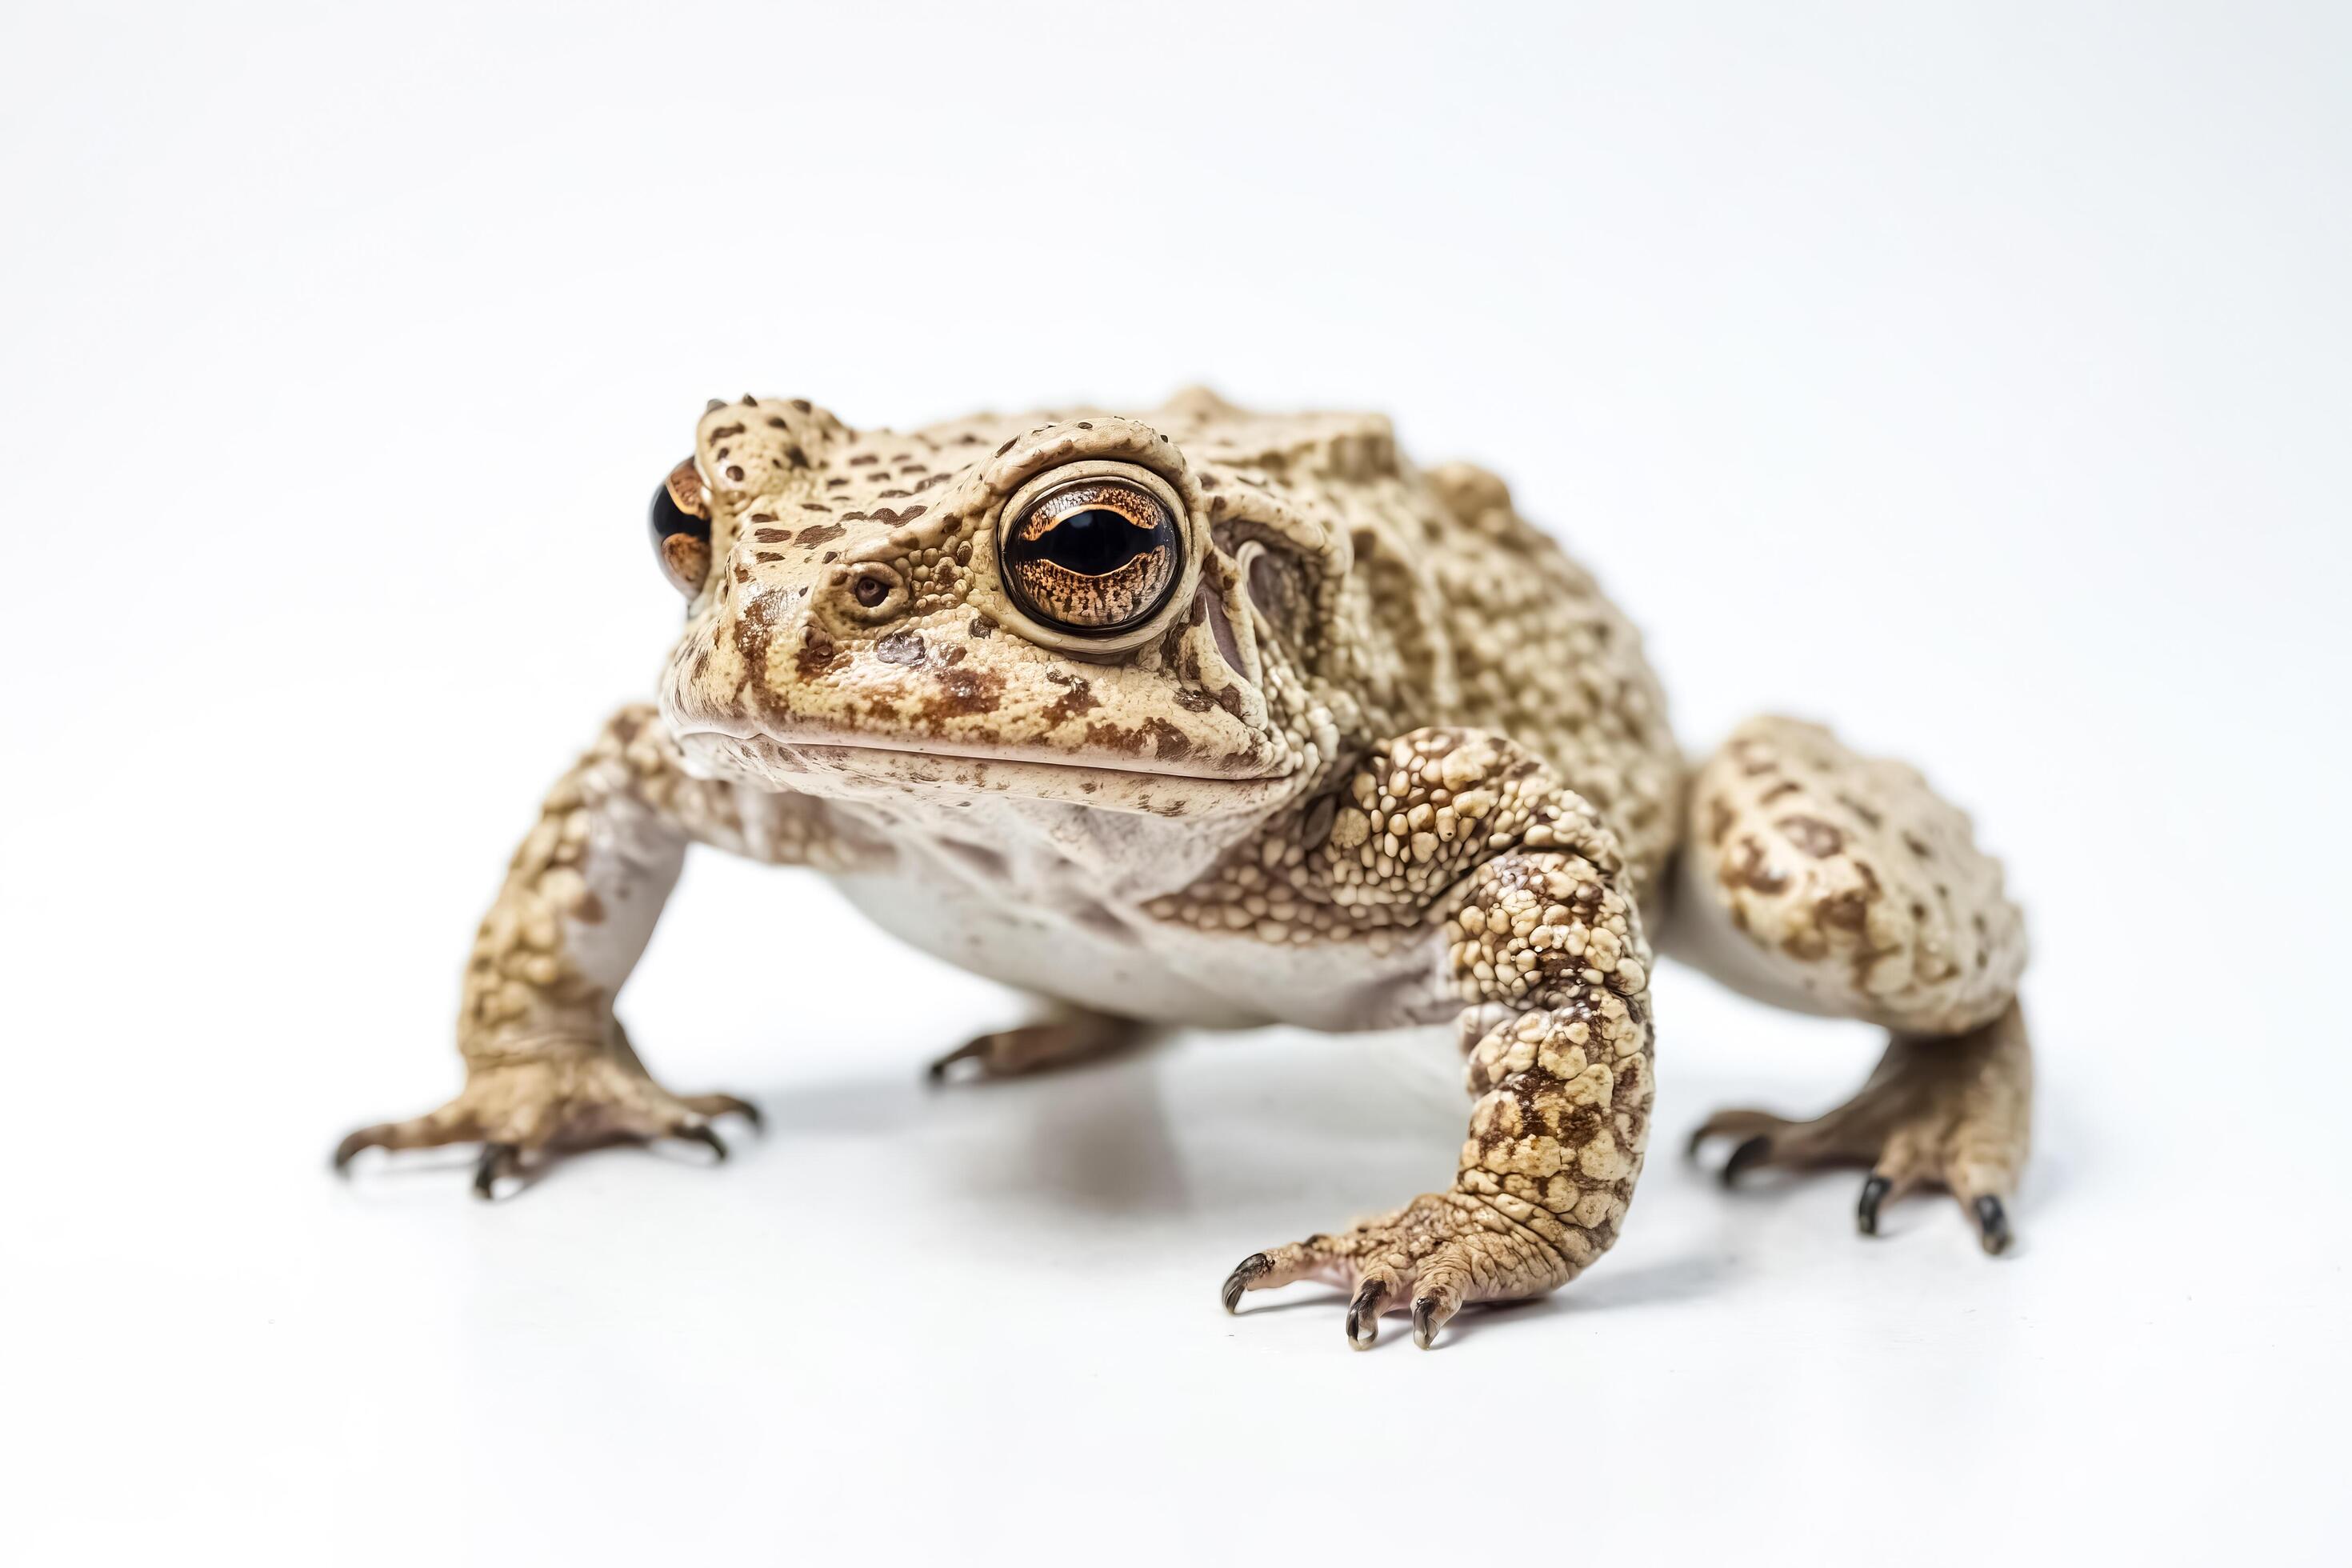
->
[1223,731,1651,1350]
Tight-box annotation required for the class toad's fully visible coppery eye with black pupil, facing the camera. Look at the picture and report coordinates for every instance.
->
[1004,478,1183,632]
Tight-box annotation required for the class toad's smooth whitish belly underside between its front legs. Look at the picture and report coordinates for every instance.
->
[833,872,1454,1030]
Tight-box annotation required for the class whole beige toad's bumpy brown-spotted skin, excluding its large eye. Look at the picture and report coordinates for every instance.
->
[341,393,2030,1345]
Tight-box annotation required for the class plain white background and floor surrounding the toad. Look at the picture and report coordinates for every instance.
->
[0,2,2352,1568]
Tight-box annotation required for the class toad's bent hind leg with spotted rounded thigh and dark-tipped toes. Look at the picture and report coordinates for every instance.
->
[1667,719,2032,1253]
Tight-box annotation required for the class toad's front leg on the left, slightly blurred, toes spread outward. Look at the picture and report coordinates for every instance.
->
[334,707,870,1197]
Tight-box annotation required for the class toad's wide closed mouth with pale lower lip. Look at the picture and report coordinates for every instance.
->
[678,729,1294,816]
